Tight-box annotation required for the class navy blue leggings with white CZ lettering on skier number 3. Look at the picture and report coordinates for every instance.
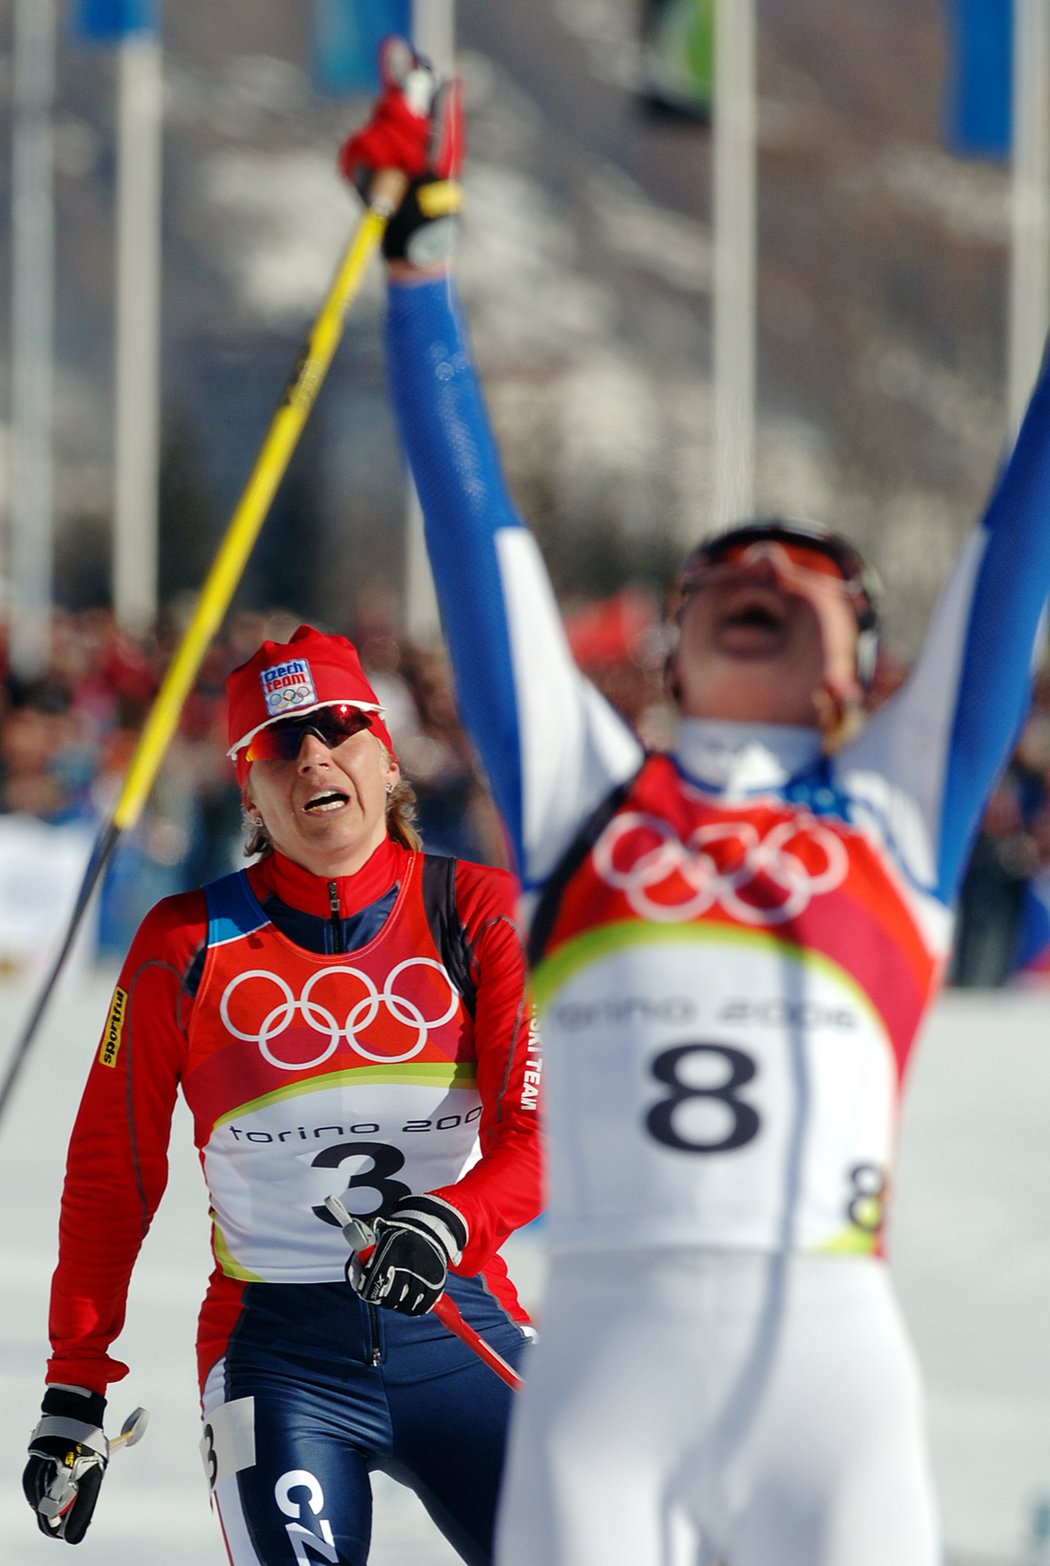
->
[202,1278,527,1566]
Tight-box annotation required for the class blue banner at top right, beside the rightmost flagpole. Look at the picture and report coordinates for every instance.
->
[945,0,1014,158]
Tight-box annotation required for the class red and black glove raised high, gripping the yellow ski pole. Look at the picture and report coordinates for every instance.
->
[339,38,464,266]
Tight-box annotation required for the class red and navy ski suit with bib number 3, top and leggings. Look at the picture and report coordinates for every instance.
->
[47,841,541,1566]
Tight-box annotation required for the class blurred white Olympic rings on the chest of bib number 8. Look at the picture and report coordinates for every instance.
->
[594,811,849,926]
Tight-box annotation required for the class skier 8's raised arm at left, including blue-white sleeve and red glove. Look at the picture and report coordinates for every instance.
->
[340,47,641,889]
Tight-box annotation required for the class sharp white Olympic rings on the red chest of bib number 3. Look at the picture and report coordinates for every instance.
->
[219,957,459,1071]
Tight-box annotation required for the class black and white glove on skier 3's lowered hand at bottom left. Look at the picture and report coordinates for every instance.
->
[22,1386,110,1544]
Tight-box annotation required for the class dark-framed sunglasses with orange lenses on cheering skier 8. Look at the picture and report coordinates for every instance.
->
[679,521,878,631]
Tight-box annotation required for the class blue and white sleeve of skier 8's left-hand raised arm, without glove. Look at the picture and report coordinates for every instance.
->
[387,280,641,886]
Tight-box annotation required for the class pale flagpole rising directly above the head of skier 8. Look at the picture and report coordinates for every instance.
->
[711,0,755,526]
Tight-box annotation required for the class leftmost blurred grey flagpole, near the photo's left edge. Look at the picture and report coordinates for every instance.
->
[6,0,55,678]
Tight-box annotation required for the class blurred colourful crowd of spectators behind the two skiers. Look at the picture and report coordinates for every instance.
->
[0,589,1050,987]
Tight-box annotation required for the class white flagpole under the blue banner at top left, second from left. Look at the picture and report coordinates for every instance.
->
[113,27,163,631]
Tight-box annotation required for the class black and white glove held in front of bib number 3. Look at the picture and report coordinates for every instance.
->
[346,1196,467,1315]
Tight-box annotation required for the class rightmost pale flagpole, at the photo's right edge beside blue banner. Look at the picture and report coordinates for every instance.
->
[1006,0,1050,432]
